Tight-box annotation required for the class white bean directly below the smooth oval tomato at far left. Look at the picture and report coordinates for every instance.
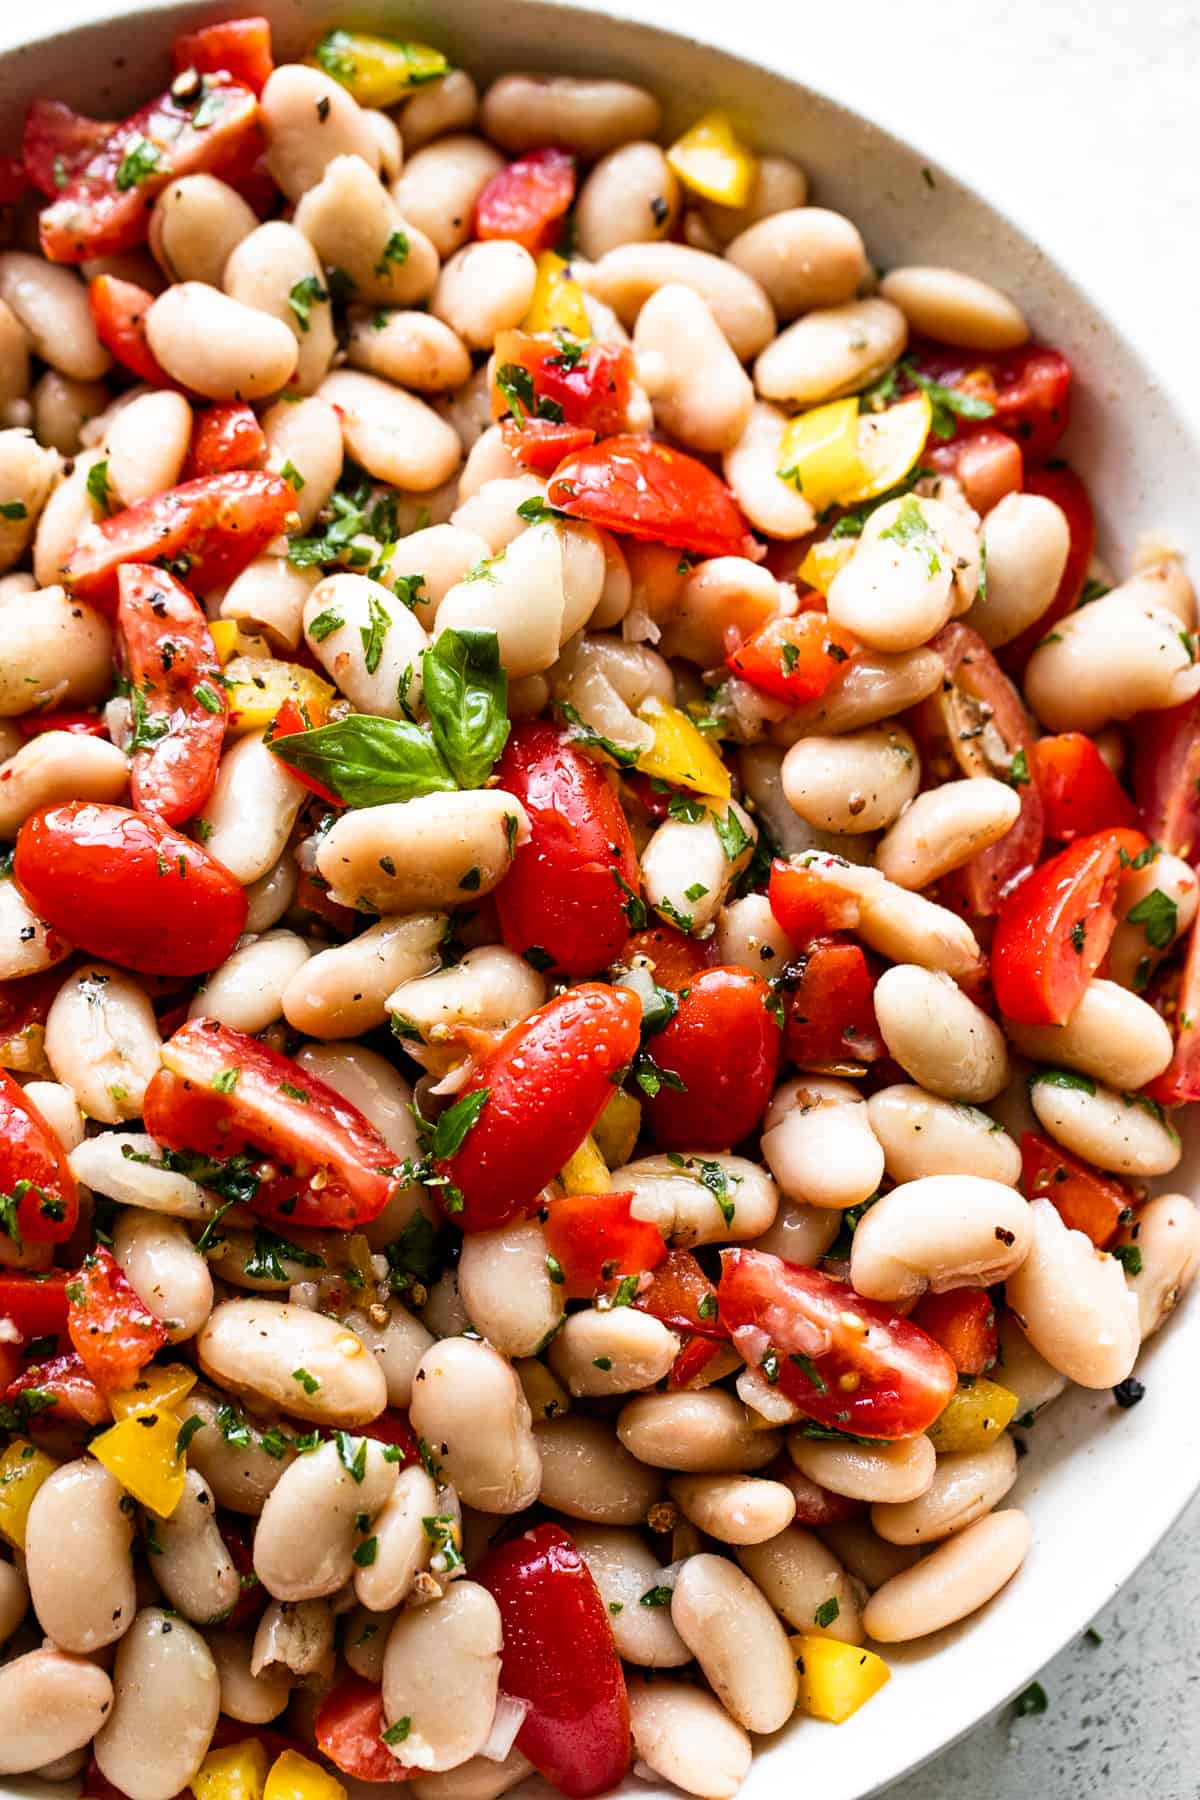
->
[45,963,162,1125]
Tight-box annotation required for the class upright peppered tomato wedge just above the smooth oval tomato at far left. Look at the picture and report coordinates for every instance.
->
[117,563,228,824]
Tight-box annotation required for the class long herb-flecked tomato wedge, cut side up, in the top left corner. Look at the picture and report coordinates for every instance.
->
[40,77,259,263]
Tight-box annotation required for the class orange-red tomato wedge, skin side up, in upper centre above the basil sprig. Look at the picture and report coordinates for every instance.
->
[547,432,765,562]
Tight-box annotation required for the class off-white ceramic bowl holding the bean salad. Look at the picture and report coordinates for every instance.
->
[0,0,1200,1800]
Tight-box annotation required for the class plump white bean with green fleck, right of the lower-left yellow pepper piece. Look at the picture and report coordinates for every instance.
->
[196,1300,387,1427]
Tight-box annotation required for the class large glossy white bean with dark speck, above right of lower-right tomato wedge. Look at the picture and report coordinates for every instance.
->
[851,1175,1034,1301]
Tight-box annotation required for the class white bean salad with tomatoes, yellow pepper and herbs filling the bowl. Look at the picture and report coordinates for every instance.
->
[0,18,1200,1800]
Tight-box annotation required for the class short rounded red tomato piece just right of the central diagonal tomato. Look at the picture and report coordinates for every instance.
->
[642,967,783,1150]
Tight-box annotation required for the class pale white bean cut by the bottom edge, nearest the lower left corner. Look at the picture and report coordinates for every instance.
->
[94,1606,221,1800]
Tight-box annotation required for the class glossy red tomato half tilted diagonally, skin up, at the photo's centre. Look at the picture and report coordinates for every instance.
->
[437,981,642,1231]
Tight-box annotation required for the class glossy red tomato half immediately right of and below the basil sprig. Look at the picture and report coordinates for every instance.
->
[495,720,640,976]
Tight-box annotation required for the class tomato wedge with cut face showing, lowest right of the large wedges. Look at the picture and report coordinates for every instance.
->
[718,1249,959,1438]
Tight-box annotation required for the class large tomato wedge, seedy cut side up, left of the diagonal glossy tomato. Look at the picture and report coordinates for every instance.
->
[144,1019,396,1231]
